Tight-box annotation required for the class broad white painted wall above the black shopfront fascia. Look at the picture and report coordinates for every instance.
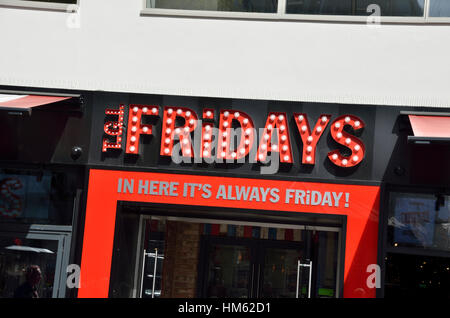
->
[0,0,450,107]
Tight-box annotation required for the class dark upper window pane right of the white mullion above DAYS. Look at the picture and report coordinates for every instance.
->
[286,0,425,17]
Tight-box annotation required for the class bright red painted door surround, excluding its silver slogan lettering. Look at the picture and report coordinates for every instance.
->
[78,170,379,298]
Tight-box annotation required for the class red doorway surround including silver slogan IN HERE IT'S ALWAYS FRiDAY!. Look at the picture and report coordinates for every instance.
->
[78,169,379,297]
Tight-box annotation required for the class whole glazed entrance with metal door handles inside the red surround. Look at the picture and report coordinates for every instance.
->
[135,216,341,298]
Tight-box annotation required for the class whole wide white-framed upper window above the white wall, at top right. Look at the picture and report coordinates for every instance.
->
[143,0,450,23]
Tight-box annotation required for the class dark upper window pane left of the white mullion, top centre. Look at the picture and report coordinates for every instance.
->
[147,0,278,13]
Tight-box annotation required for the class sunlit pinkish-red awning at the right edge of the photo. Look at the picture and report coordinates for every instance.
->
[409,115,450,138]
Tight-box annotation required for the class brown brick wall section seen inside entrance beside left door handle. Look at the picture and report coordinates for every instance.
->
[161,221,201,298]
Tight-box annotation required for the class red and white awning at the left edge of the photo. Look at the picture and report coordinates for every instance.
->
[0,94,72,111]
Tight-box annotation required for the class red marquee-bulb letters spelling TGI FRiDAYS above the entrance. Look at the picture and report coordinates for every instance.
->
[102,105,365,168]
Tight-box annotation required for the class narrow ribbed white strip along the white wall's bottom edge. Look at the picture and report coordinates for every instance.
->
[0,76,450,108]
